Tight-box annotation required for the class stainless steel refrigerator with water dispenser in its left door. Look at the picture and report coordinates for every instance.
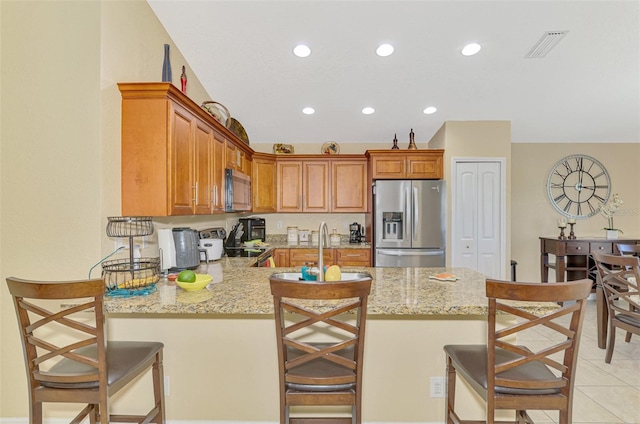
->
[373,180,446,267]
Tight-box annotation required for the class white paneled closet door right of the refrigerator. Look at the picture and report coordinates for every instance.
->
[451,160,507,279]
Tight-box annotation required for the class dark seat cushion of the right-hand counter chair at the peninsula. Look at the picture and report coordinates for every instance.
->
[444,345,560,395]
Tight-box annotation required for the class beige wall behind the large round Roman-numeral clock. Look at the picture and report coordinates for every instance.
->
[511,140,640,281]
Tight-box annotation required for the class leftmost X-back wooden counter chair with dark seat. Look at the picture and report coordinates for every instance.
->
[7,277,165,424]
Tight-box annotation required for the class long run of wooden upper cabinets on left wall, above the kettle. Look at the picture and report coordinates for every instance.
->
[118,83,253,216]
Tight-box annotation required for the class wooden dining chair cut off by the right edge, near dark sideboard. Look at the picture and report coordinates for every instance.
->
[591,252,640,364]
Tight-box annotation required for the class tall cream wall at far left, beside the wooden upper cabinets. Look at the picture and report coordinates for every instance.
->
[0,0,208,418]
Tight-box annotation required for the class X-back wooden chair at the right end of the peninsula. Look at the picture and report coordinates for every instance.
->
[444,279,592,424]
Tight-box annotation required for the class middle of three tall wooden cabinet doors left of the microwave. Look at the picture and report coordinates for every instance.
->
[194,120,213,215]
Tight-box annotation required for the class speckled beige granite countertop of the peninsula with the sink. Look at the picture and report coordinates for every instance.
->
[105,257,552,318]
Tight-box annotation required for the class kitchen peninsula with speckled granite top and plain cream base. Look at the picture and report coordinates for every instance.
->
[105,257,552,423]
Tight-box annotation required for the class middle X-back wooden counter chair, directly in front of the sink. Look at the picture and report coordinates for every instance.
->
[270,277,371,424]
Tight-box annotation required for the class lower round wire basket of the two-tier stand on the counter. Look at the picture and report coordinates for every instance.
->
[102,258,160,291]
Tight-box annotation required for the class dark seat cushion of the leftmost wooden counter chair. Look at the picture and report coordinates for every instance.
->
[41,341,164,389]
